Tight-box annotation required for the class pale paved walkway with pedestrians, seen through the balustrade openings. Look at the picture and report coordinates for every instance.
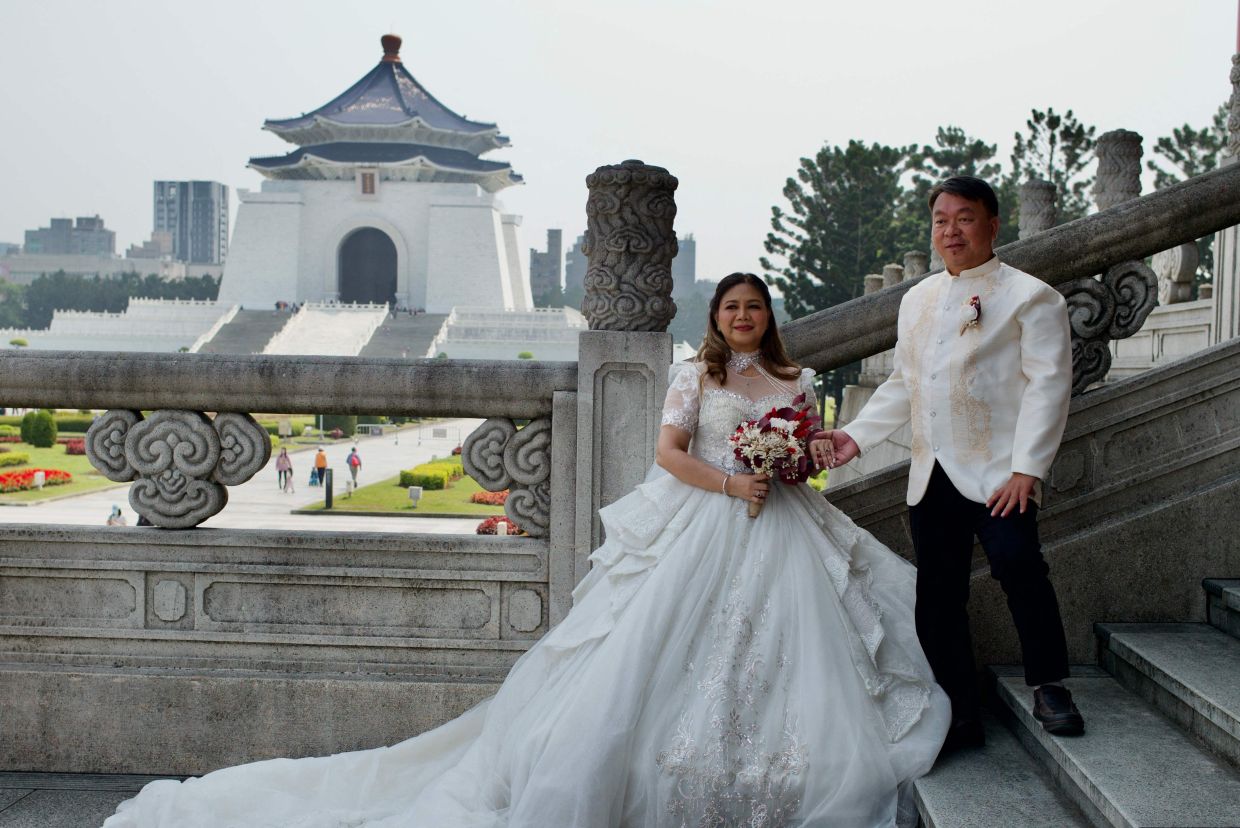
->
[0,419,481,532]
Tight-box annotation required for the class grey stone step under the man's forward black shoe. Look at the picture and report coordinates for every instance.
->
[992,667,1240,828]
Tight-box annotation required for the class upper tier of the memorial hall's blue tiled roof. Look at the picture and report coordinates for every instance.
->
[267,61,495,133]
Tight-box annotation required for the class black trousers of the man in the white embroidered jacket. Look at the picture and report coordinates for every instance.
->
[909,464,1068,719]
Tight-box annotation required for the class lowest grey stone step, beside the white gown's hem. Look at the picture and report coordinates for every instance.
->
[914,713,1091,828]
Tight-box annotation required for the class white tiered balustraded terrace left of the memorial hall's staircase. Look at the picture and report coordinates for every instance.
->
[0,299,237,352]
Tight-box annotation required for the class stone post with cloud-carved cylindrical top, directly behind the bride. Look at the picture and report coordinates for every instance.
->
[574,160,678,565]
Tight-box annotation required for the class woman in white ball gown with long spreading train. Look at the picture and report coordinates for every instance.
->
[104,273,950,828]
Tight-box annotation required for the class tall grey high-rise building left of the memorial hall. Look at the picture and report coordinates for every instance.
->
[155,181,228,264]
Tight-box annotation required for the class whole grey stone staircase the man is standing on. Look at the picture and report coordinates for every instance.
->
[916,579,1240,828]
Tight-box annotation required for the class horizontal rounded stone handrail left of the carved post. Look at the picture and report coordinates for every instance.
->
[0,351,577,419]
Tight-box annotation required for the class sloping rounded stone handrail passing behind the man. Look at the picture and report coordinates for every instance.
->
[782,164,1240,372]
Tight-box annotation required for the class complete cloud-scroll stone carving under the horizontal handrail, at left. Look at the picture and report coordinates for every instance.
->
[86,410,272,529]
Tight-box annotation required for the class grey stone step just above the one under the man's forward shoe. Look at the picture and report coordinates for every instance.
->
[1097,623,1240,768]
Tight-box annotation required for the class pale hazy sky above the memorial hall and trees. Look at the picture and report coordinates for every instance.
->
[0,0,1236,278]
